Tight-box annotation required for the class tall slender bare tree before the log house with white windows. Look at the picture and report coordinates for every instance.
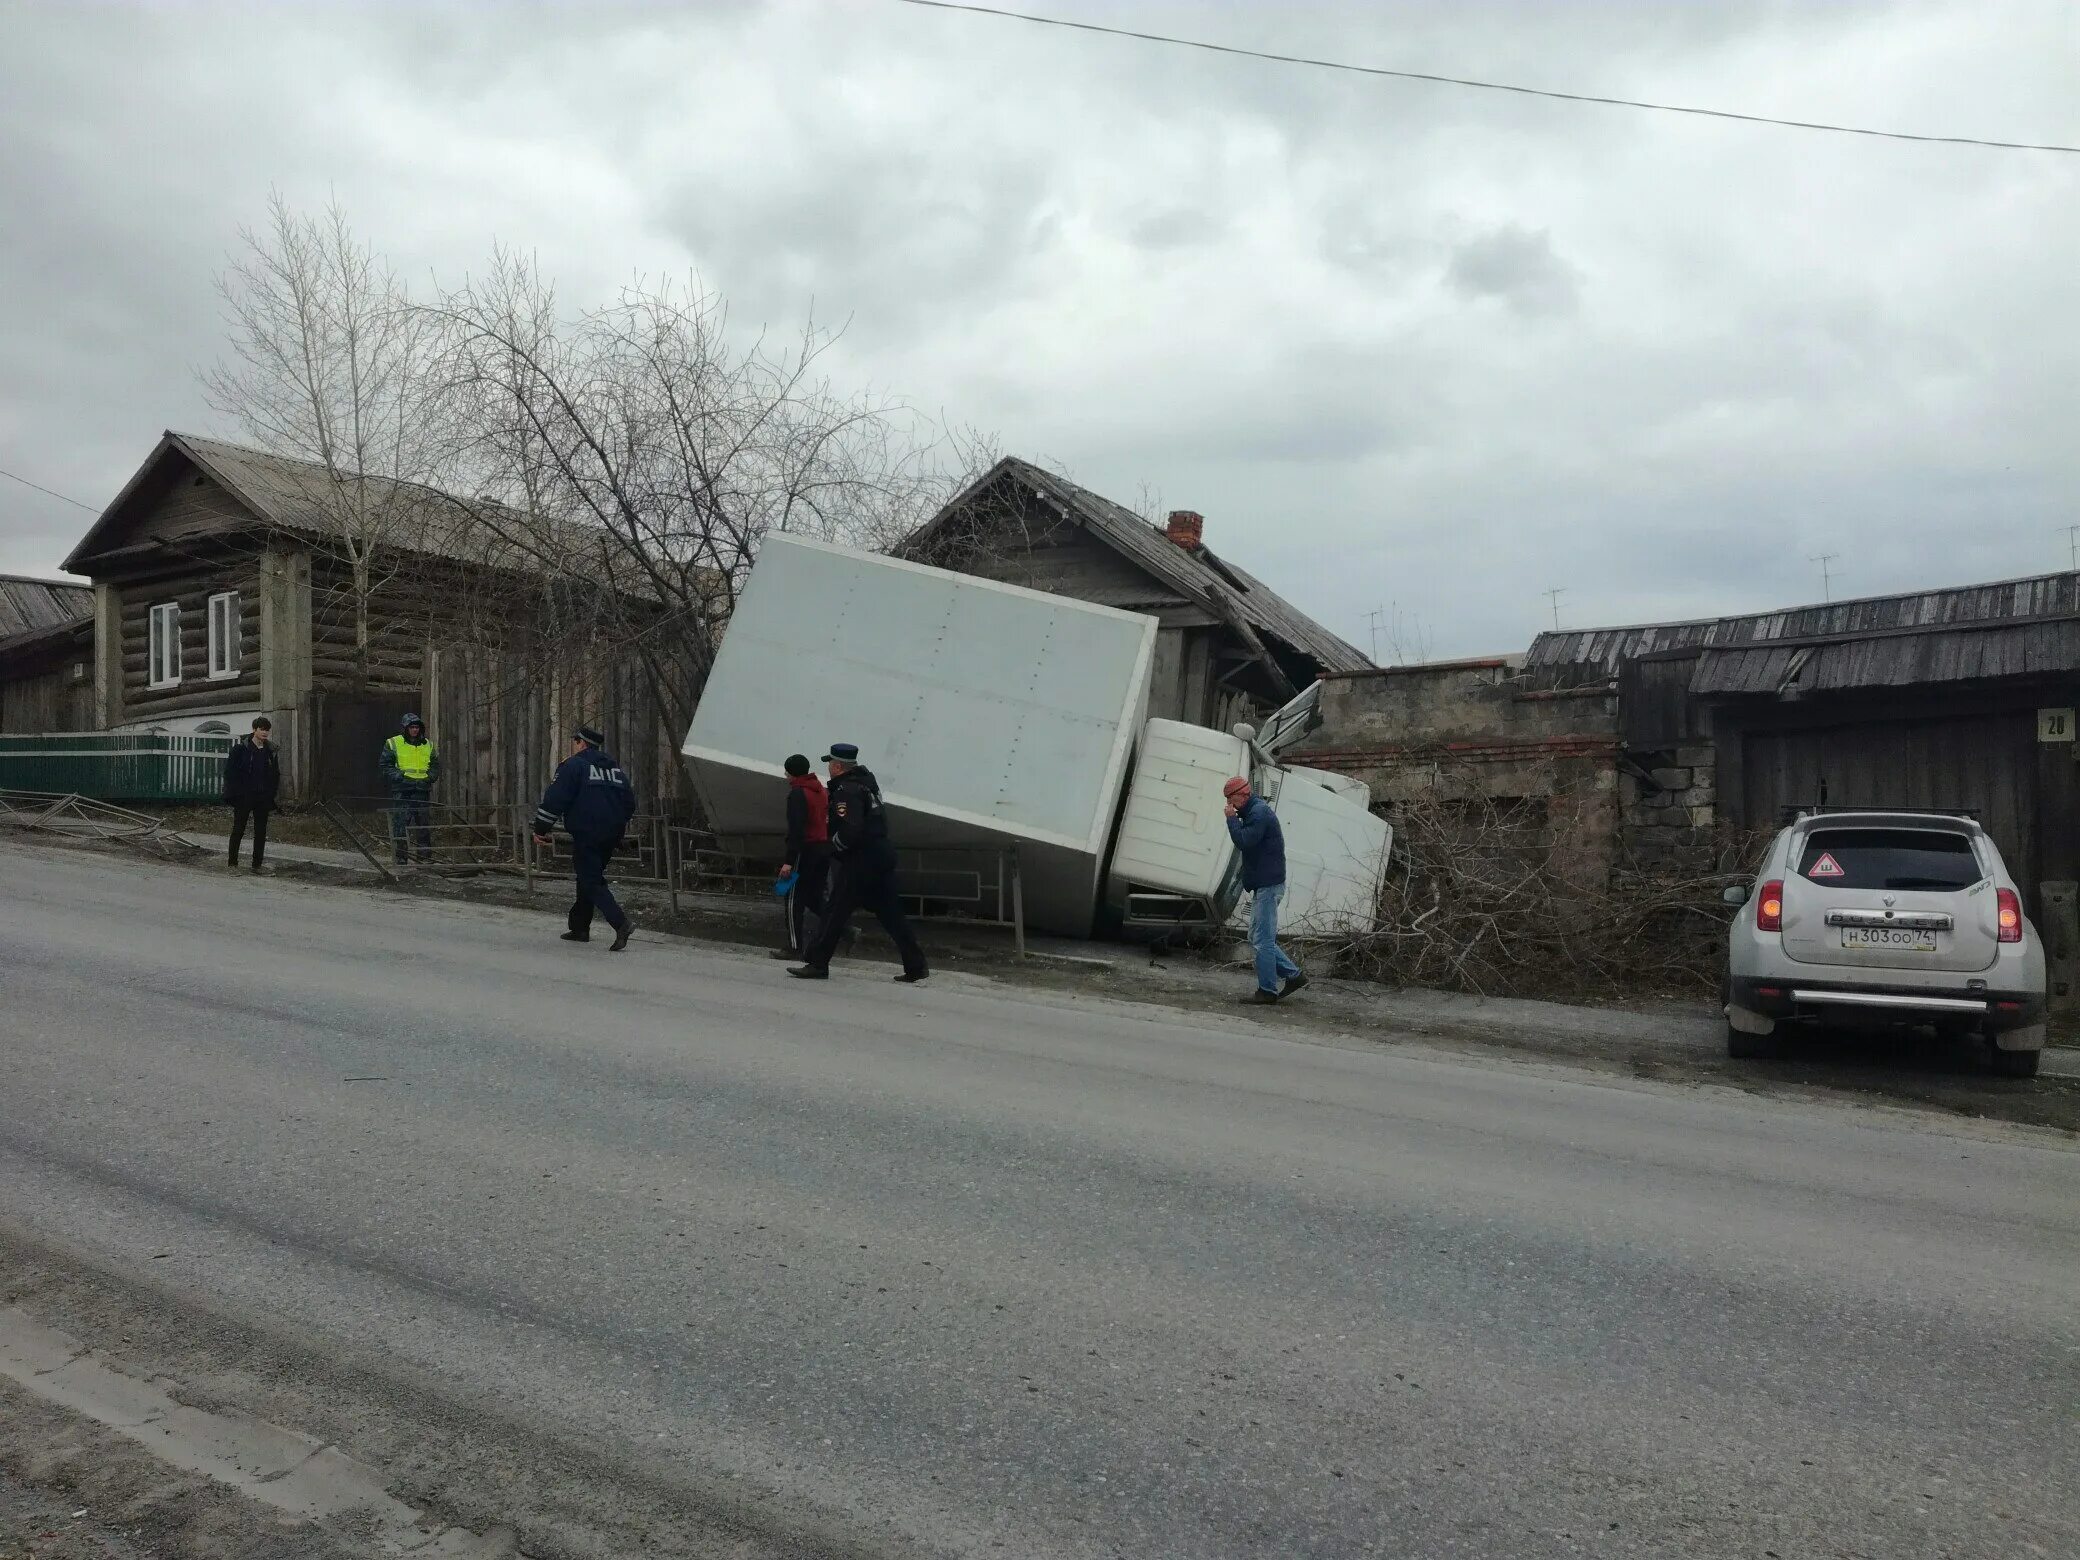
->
[202,191,435,682]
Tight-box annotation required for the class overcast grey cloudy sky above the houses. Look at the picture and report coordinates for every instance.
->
[0,0,2080,655]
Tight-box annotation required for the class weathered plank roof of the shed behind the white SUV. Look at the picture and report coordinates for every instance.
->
[1527,570,2080,695]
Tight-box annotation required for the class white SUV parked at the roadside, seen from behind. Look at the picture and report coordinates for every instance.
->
[1726,809,2045,1077]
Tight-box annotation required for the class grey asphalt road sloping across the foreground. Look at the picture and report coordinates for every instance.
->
[0,844,2080,1560]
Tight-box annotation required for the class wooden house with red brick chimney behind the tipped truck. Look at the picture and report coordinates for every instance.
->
[896,458,1371,730]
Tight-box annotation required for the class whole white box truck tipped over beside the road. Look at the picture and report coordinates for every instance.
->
[684,537,1389,936]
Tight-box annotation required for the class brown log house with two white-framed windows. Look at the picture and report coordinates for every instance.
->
[64,433,682,807]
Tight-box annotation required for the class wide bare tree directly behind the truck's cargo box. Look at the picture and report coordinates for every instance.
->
[433,250,980,744]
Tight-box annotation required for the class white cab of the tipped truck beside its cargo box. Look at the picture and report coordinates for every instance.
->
[1104,720,1250,930]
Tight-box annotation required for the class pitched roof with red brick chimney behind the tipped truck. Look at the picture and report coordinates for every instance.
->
[896,456,1371,672]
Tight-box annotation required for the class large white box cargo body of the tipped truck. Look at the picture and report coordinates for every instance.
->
[682,535,1156,936]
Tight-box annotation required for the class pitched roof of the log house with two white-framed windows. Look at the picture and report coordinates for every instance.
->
[64,428,628,570]
